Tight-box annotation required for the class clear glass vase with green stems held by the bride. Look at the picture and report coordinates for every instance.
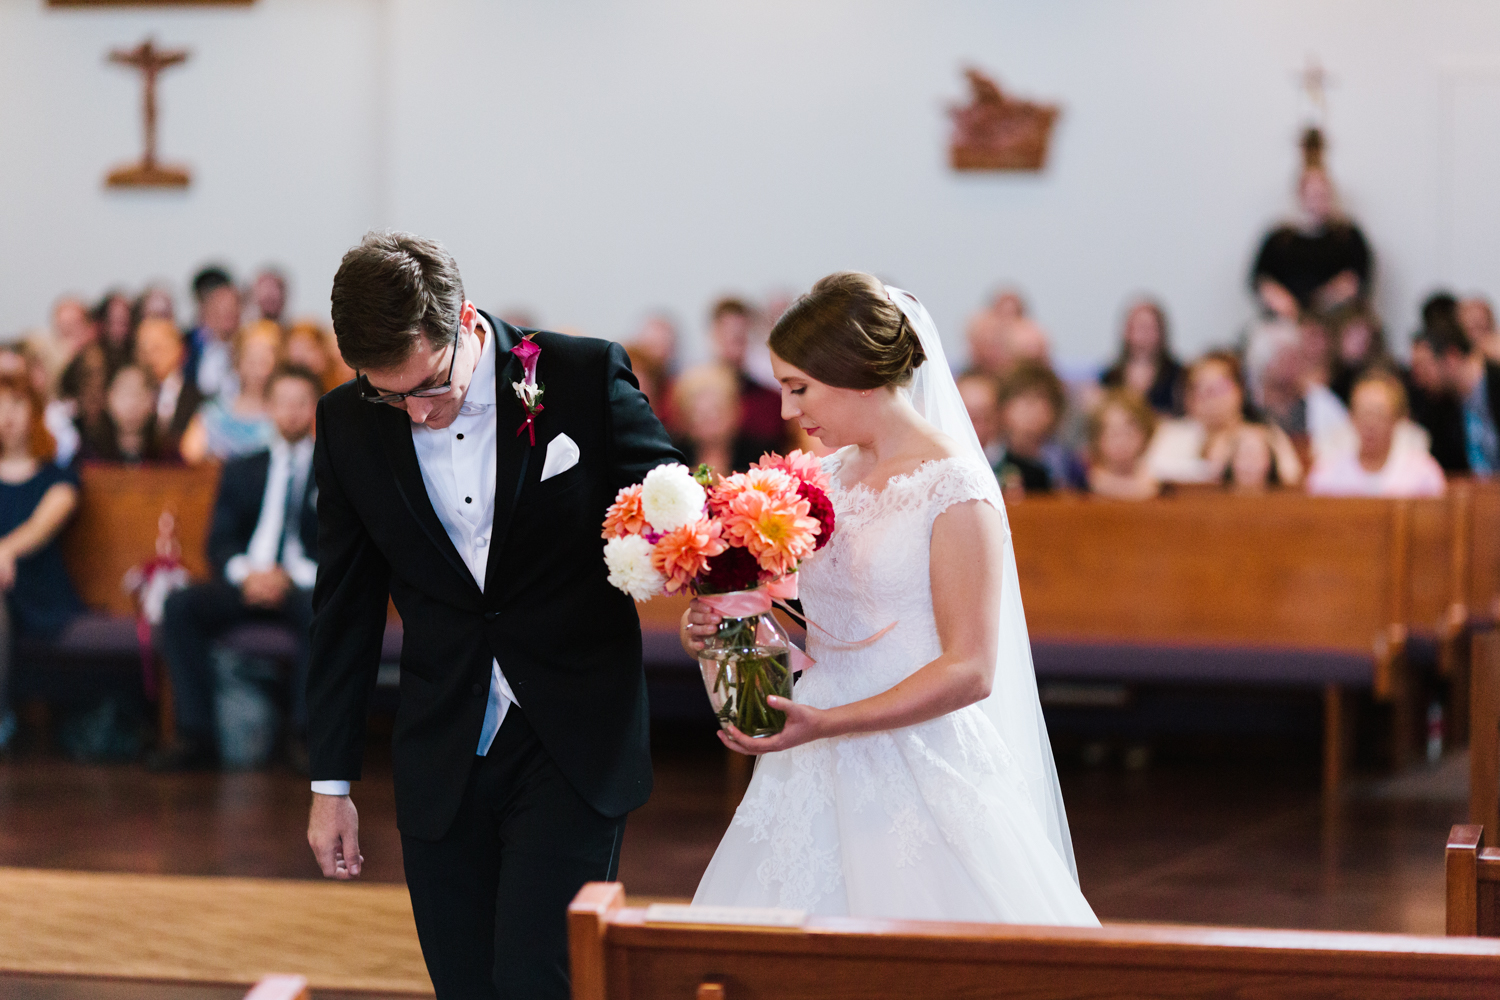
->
[698,599,792,736]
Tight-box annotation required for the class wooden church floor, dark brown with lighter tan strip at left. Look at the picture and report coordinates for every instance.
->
[0,730,1467,1000]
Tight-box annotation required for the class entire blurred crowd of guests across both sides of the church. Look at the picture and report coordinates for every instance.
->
[11,121,1500,758]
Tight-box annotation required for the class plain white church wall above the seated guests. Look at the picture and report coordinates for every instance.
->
[0,0,1500,361]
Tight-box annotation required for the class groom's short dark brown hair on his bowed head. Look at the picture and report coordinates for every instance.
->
[333,231,464,369]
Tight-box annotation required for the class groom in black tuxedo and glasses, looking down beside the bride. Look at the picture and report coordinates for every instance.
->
[308,232,681,1000]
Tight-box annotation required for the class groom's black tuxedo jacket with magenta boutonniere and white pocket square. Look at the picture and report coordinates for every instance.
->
[308,315,681,840]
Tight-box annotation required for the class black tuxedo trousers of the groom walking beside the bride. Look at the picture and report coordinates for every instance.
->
[401,705,626,1000]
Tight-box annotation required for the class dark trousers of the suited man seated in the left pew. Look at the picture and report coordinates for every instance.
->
[158,580,312,742]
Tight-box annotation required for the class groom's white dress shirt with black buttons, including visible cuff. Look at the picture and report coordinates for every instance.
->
[312,316,519,795]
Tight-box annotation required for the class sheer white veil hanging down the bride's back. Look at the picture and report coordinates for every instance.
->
[885,285,1079,882]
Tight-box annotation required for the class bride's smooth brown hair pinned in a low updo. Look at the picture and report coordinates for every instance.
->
[771,271,927,390]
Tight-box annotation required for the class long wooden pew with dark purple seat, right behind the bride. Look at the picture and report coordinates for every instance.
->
[1010,492,1416,790]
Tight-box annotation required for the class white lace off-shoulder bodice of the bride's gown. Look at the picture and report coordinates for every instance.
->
[797,448,1005,708]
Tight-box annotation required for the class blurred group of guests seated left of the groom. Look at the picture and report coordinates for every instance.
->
[0,267,343,751]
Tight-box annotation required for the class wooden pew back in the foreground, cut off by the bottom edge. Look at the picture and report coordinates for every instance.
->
[569,883,1500,1000]
